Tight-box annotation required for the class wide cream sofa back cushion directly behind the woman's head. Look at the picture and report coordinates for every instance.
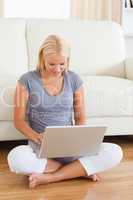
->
[26,19,125,77]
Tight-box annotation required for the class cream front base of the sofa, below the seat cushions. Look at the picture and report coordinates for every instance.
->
[0,117,133,141]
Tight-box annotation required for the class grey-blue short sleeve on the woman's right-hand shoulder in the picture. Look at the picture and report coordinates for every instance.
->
[69,71,83,92]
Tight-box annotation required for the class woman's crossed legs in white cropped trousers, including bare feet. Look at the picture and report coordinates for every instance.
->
[8,143,122,188]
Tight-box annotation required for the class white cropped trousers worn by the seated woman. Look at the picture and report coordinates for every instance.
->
[7,143,123,176]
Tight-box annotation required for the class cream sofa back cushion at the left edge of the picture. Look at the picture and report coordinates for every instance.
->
[0,18,28,75]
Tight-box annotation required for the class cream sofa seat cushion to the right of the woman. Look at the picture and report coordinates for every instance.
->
[82,76,133,118]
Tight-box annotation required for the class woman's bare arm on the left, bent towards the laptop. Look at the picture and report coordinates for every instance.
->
[14,82,42,144]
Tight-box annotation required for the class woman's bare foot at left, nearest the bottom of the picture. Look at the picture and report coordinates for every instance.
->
[29,173,51,188]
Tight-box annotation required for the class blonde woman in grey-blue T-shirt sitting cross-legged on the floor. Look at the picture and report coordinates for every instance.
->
[8,35,122,188]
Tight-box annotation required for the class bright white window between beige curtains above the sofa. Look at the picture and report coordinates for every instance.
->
[4,0,71,19]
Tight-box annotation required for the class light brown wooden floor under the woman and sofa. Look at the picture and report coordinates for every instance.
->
[0,136,133,200]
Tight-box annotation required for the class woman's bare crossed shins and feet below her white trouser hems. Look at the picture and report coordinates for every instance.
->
[29,160,100,188]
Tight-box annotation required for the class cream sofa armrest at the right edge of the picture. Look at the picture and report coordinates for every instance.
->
[125,57,133,80]
